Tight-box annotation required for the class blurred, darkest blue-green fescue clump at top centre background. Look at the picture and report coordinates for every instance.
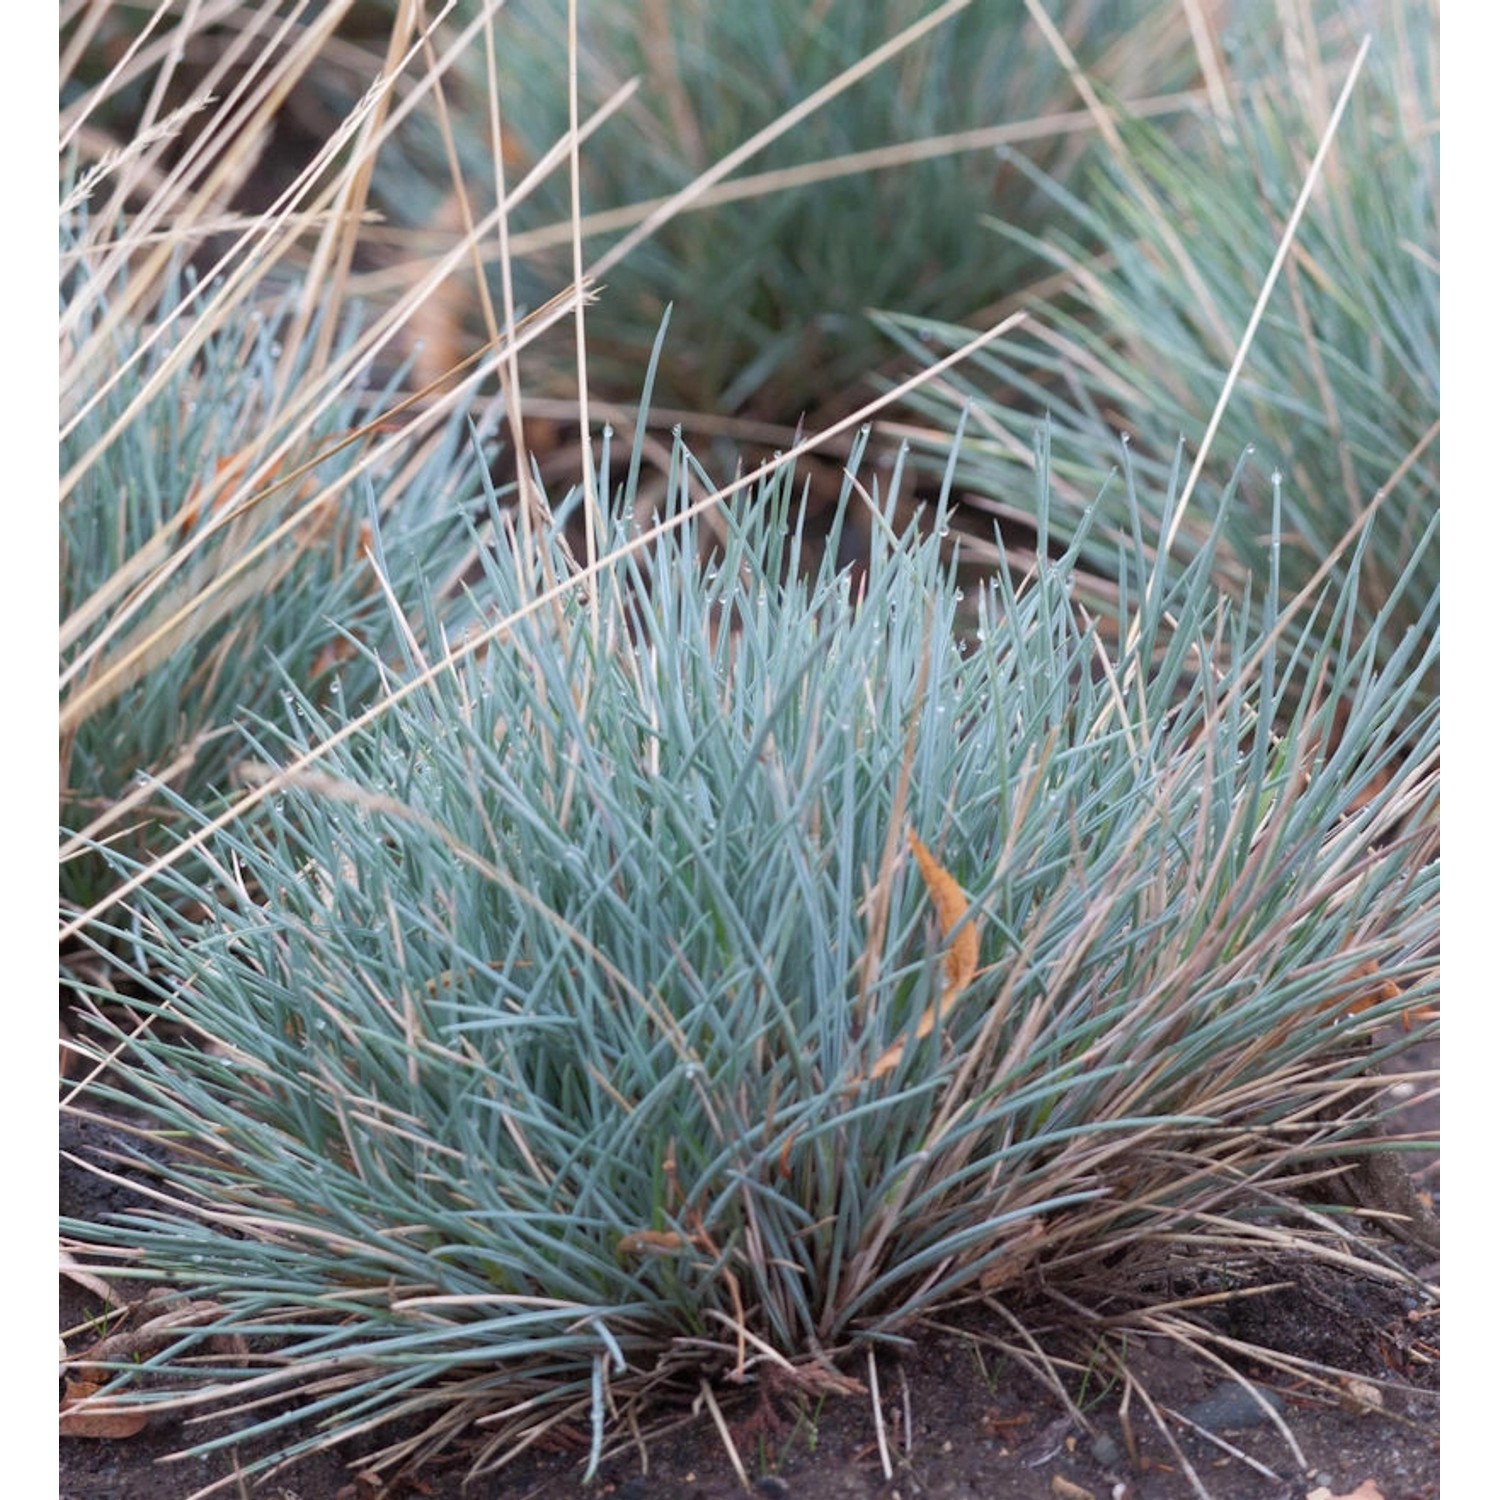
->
[298,0,1196,426]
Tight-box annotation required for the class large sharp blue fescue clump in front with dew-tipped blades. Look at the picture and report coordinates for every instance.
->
[65,420,1437,1467]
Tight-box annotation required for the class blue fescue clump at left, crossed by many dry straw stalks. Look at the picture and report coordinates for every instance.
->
[59,210,498,908]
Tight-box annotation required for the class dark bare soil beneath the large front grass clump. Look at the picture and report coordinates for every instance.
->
[60,1044,1440,1500]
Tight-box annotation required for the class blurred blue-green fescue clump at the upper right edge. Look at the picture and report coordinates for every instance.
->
[887,0,1440,692]
